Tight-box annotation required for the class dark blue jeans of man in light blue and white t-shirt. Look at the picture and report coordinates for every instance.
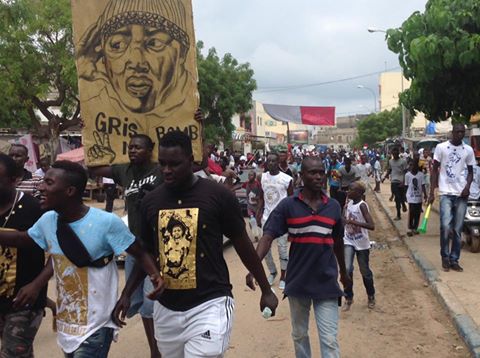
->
[65,327,113,358]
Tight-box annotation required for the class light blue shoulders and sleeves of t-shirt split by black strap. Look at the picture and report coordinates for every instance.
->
[28,208,135,260]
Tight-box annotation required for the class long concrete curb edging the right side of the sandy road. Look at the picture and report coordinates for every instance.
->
[371,190,480,358]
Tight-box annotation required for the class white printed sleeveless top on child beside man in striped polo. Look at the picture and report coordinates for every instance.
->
[343,200,370,251]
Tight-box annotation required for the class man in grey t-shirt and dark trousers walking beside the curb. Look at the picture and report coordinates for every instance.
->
[382,147,408,220]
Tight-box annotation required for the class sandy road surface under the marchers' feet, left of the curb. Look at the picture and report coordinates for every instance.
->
[30,197,470,358]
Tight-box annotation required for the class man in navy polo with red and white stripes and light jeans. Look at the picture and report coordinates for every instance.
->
[247,157,350,358]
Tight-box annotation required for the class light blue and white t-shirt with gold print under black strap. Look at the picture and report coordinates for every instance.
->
[28,208,135,353]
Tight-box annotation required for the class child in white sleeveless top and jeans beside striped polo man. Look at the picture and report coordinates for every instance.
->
[343,181,375,310]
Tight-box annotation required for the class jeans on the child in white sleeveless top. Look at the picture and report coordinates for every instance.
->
[344,245,375,299]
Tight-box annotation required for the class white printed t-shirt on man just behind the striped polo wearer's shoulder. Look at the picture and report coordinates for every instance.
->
[261,172,292,225]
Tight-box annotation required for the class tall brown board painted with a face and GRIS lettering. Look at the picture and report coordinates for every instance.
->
[72,0,202,166]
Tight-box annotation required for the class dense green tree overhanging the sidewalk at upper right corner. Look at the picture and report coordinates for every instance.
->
[386,0,480,121]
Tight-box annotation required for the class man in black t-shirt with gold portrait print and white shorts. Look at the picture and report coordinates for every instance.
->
[113,131,278,357]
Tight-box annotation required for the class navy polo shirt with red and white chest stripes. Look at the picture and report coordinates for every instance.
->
[263,191,343,300]
